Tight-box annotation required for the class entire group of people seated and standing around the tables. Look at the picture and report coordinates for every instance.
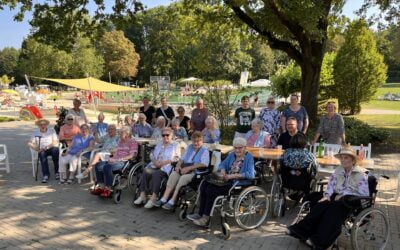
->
[28,95,369,246]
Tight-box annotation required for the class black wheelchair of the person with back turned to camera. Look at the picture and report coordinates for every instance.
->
[270,160,317,217]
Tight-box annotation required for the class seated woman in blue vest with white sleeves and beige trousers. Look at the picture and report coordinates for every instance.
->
[160,131,210,210]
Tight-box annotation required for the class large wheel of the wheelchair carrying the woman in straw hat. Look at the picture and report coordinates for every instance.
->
[351,208,389,250]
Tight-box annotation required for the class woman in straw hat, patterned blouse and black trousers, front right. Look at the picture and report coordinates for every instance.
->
[287,147,369,249]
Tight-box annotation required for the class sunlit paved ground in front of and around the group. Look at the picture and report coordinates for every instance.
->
[0,122,400,249]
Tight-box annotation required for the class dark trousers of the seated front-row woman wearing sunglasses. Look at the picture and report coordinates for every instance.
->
[140,168,168,195]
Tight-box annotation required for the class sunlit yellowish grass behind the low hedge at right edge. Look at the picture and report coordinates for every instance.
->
[355,115,400,153]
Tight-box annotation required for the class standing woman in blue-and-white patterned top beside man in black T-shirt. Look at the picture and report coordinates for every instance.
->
[259,96,281,147]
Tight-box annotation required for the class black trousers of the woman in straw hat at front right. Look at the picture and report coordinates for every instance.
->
[289,201,350,249]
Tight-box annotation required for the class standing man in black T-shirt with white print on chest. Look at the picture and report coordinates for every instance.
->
[235,96,256,139]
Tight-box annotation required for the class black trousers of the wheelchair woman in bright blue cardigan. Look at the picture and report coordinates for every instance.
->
[199,181,232,216]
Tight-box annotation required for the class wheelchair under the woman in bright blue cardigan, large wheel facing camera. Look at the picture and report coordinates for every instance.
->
[208,178,269,240]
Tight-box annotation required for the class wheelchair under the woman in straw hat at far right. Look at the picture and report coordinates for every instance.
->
[292,172,389,250]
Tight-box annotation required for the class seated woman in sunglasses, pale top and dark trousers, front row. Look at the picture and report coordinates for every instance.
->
[133,127,181,209]
